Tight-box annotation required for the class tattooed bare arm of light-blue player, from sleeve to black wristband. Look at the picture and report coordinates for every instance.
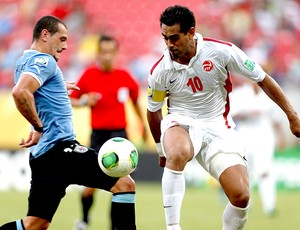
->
[12,74,43,128]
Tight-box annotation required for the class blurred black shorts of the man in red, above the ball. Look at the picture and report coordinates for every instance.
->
[90,129,127,152]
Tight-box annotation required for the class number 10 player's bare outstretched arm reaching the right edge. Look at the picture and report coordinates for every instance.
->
[257,75,300,137]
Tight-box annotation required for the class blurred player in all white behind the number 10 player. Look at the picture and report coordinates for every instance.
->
[230,80,285,216]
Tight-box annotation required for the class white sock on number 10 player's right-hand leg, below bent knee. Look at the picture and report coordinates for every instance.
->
[222,202,249,230]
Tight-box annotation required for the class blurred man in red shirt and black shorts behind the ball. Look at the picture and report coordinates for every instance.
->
[70,35,146,230]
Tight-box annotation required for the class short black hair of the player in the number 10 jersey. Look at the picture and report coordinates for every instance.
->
[160,5,196,34]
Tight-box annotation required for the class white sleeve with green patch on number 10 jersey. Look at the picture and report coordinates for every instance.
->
[227,45,266,82]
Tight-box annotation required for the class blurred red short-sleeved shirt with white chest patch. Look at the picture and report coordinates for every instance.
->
[70,66,139,130]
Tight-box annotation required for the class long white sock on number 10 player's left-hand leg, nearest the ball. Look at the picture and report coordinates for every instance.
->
[162,168,185,230]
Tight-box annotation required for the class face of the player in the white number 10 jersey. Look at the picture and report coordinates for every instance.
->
[161,24,194,60]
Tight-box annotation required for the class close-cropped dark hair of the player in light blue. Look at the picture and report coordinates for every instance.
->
[32,15,67,41]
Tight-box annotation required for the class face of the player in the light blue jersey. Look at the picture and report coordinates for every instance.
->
[48,24,68,61]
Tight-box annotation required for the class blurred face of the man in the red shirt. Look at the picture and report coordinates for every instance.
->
[98,41,118,71]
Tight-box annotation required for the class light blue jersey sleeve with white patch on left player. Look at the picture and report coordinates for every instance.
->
[22,53,57,85]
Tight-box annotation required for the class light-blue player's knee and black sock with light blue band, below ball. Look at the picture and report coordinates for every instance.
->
[110,176,136,230]
